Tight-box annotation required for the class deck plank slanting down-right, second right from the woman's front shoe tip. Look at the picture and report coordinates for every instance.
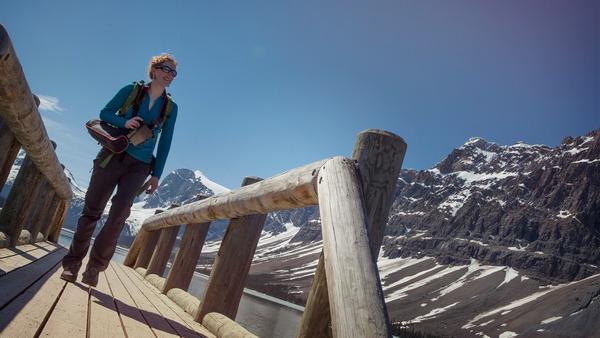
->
[104,264,155,337]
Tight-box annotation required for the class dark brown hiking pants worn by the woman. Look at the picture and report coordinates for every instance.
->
[62,148,150,272]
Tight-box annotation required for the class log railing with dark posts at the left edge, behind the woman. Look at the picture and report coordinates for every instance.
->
[0,25,72,247]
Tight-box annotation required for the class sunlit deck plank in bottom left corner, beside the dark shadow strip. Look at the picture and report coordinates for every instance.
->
[0,251,67,337]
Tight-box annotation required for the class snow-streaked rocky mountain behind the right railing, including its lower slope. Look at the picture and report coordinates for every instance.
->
[195,130,600,337]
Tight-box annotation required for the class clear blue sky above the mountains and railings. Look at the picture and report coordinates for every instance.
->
[0,0,600,188]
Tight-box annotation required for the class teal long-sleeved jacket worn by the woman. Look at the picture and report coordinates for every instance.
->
[100,84,177,179]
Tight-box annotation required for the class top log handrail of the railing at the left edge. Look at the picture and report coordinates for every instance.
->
[0,25,73,201]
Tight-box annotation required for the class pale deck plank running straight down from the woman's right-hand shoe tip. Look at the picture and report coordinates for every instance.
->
[88,271,126,338]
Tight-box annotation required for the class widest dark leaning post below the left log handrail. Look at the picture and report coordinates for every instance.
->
[0,156,42,246]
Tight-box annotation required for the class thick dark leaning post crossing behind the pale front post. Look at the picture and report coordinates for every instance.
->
[298,129,406,337]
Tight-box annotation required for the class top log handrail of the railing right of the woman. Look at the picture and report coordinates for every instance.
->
[142,160,327,231]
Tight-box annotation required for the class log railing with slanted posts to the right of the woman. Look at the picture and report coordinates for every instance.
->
[124,130,406,337]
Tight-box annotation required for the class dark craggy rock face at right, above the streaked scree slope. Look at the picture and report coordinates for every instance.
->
[384,130,600,282]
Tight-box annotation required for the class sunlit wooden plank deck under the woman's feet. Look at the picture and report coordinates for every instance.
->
[0,242,215,338]
